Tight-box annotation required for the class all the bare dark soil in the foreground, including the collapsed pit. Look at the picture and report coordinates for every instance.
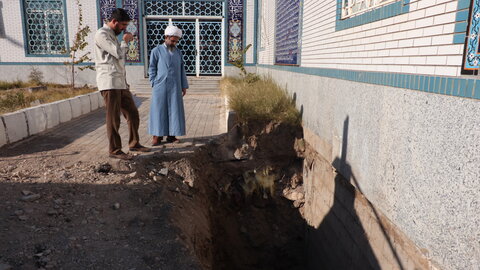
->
[0,123,305,269]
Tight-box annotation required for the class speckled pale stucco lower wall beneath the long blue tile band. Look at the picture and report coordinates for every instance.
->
[258,67,480,269]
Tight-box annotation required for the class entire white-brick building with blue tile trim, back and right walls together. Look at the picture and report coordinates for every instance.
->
[0,0,480,269]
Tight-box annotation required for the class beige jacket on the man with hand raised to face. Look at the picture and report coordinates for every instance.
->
[95,24,129,91]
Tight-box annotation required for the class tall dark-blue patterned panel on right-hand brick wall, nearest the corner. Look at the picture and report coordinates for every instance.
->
[275,0,301,65]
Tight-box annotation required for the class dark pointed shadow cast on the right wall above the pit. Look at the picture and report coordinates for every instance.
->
[307,117,405,270]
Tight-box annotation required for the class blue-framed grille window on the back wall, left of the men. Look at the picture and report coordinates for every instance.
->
[22,0,67,55]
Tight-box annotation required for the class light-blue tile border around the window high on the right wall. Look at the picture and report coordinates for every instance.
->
[335,0,410,31]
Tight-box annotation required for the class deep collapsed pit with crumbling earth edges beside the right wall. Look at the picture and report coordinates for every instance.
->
[137,123,306,269]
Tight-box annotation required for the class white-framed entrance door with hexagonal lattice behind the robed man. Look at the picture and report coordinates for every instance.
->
[144,0,224,76]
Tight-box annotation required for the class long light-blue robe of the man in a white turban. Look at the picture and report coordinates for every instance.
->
[148,44,188,136]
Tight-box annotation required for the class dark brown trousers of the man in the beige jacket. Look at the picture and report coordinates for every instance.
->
[101,89,140,154]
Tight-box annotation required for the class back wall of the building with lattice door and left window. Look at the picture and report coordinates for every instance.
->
[0,0,255,84]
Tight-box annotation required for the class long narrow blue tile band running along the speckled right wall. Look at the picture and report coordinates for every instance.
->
[257,64,480,99]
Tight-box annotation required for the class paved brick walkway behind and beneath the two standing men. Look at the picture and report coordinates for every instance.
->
[0,80,226,165]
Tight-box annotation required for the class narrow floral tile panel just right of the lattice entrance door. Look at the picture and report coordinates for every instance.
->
[227,0,243,62]
